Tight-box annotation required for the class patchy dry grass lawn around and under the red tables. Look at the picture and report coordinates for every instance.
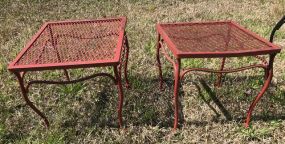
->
[0,0,285,143]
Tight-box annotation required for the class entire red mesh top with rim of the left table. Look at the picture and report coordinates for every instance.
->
[9,17,126,70]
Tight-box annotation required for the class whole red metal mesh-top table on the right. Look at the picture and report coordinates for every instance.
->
[156,21,281,129]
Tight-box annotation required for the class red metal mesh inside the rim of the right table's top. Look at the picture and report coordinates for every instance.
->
[160,21,278,53]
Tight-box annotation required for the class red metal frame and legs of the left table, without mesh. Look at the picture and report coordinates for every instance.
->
[8,17,130,128]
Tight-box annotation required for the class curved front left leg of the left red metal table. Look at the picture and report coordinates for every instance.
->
[15,72,49,127]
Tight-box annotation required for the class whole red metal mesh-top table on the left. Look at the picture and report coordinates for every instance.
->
[8,17,129,127]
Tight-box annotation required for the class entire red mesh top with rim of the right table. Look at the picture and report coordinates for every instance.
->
[157,21,281,58]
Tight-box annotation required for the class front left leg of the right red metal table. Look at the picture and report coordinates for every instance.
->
[173,59,181,130]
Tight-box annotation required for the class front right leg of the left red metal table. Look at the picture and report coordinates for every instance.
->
[114,66,124,128]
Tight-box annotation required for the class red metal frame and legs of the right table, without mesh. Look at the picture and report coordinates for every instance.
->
[156,22,281,130]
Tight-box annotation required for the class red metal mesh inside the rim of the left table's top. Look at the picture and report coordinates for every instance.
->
[15,19,122,66]
